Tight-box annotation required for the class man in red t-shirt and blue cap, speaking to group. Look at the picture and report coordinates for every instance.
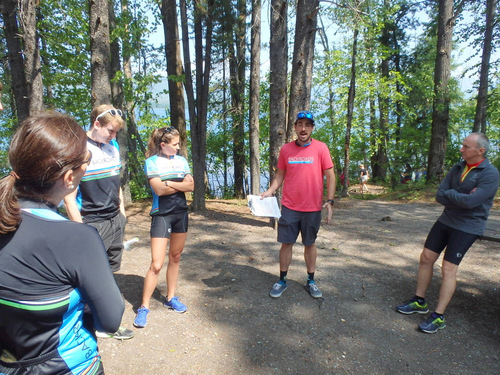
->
[261,111,335,298]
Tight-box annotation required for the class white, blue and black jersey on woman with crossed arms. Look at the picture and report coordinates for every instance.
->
[144,155,191,216]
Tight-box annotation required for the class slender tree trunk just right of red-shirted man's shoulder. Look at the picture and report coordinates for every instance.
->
[341,29,359,197]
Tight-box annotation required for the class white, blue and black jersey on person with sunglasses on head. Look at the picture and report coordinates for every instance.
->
[76,138,122,223]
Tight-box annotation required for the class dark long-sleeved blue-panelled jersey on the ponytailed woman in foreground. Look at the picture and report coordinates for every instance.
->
[0,199,124,374]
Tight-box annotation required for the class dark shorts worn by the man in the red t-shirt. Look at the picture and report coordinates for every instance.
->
[278,206,321,246]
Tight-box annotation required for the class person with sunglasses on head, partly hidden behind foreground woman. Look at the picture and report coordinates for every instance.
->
[64,104,134,340]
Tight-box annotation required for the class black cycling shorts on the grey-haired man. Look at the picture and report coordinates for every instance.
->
[424,221,479,266]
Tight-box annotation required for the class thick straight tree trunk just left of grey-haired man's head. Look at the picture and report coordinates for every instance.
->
[427,0,455,182]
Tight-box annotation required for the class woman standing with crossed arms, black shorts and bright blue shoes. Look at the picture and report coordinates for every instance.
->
[134,126,194,328]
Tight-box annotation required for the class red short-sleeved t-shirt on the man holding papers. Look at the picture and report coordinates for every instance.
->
[278,139,333,212]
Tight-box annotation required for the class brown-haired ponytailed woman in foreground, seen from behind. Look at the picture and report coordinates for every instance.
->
[0,112,124,375]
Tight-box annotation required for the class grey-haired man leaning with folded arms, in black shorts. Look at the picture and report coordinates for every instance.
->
[396,133,499,333]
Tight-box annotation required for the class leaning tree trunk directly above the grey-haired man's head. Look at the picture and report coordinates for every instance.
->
[473,0,497,133]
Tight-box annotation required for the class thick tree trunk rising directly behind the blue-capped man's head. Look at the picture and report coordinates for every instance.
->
[286,0,319,141]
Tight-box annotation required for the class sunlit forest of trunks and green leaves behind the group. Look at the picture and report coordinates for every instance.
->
[0,0,500,210]
